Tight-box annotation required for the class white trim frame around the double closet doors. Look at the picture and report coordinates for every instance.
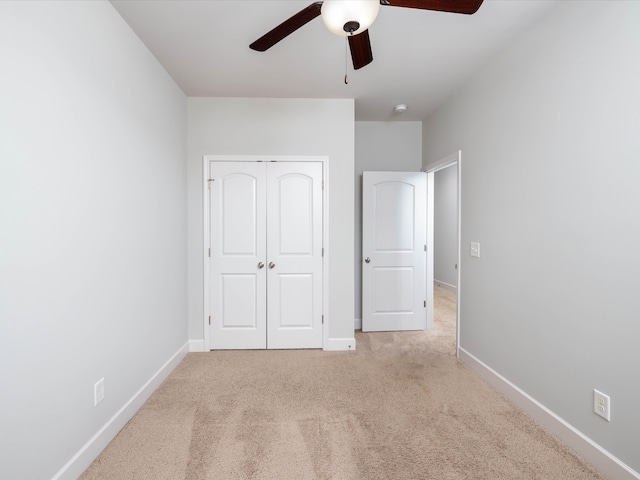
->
[202,155,330,352]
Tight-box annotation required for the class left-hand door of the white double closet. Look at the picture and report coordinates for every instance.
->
[209,162,267,350]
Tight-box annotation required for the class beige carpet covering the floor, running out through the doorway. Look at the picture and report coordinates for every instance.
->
[81,288,604,480]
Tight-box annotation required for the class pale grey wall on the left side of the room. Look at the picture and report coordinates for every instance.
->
[0,1,187,480]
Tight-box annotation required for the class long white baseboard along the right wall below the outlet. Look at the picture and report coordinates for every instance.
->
[459,348,640,480]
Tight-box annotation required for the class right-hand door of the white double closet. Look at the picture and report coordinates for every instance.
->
[267,162,323,348]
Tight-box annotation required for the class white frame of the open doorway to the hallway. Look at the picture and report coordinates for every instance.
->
[422,150,462,358]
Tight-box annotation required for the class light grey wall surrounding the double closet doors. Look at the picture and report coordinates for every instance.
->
[188,98,354,348]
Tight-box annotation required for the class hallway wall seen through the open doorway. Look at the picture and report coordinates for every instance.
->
[433,165,458,287]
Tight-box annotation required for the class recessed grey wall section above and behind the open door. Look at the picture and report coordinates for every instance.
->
[354,122,422,325]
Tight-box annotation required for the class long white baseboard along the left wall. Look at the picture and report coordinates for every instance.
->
[52,342,189,480]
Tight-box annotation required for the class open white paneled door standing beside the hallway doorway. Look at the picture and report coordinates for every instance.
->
[362,172,427,332]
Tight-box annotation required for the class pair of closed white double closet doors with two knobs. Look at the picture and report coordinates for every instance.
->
[209,162,323,349]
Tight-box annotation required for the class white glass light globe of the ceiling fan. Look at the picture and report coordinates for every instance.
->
[321,0,380,37]
